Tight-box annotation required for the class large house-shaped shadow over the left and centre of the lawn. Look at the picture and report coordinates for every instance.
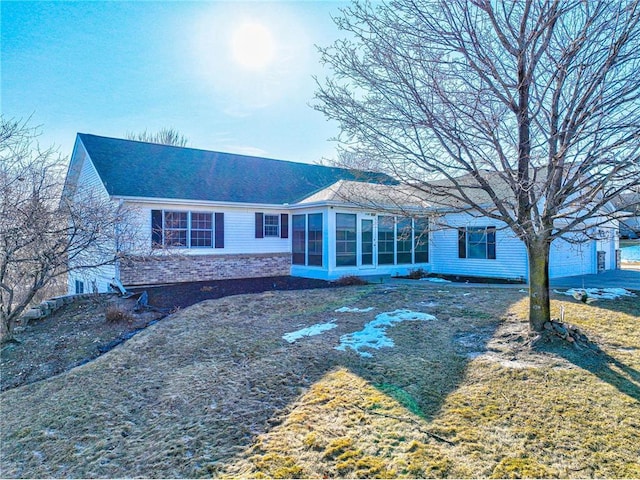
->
[0,285,509,478]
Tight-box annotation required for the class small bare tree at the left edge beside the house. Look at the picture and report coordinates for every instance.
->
[0,117,129,343]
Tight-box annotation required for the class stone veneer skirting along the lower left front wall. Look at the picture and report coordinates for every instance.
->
[119,253,291,285]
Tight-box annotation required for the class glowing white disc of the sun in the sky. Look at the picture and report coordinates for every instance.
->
[231,22,276,70]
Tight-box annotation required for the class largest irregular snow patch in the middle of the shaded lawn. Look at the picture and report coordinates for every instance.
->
[335,309,436,357]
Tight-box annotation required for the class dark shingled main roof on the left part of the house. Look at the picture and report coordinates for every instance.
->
[78,133,394,205]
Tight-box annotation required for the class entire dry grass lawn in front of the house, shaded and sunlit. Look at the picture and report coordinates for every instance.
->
[0,282,640,478]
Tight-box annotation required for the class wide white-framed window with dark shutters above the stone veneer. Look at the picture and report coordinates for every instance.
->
[151,210,224,248]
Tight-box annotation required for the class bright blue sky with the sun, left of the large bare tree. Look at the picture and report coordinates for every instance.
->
[0,0,345,162]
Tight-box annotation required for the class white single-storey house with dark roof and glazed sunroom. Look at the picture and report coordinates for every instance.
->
[65,134,617,292]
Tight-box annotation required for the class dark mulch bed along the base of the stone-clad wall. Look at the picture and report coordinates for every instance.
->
[131,276,336,311]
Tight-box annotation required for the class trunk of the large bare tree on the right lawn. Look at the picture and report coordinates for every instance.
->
[527,237,551,332]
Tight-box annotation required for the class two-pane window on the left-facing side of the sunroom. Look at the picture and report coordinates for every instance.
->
[291,213,322,267]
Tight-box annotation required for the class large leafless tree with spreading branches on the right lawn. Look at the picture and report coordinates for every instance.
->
[314,0,640,331]
